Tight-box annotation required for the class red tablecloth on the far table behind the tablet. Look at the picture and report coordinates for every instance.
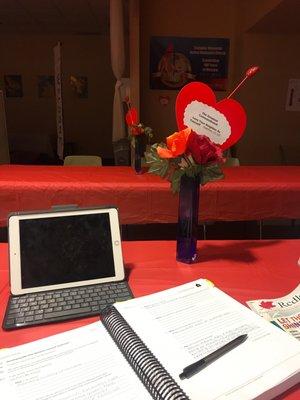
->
[0,165,300,226]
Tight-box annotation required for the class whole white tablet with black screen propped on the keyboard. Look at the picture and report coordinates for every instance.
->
[8,207,124,295]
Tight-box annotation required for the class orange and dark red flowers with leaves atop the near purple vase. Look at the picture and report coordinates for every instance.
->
[146,128,224,193]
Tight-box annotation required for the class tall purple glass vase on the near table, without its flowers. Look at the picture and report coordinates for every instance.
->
[176,175,200,264]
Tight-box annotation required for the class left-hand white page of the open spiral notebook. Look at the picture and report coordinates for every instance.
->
[0,322,151,400]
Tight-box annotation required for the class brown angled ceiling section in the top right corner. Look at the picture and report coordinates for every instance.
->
[249,0,300,35]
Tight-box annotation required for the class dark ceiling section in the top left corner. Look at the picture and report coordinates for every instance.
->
[0,0,109,35]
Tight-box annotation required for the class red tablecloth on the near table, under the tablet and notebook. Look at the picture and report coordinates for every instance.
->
[0,240,300,400]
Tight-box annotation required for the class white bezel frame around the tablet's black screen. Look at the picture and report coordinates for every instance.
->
[8,207,125,295]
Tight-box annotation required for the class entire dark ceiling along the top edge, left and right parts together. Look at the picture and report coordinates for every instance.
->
[0,0,300,35]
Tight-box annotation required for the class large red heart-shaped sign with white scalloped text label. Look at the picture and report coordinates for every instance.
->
[175,82,247,150]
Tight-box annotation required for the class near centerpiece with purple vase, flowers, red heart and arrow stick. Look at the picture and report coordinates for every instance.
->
[146,67,258,263]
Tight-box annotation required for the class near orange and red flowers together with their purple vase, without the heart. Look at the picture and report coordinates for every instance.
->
[146,128,225,263]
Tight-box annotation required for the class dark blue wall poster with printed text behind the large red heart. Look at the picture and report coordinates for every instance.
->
[150,36,230,91]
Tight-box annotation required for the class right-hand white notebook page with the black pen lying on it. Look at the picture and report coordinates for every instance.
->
[115,280,300,400]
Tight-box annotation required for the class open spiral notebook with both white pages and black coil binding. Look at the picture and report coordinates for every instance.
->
[0,280,300,400]
